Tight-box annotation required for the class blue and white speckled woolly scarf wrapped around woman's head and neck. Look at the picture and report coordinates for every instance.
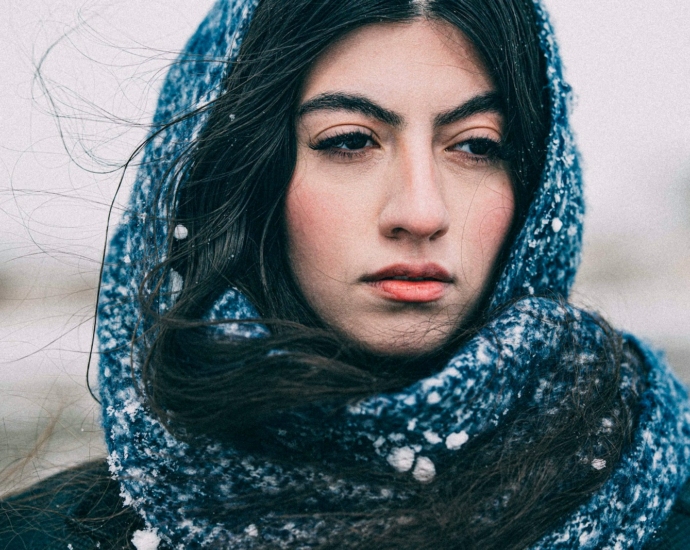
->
[98,0,690,549]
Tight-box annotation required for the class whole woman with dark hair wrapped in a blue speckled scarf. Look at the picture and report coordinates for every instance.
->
[3,0,690,550]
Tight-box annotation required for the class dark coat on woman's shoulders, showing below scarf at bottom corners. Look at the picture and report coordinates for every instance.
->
[0,462,690,550]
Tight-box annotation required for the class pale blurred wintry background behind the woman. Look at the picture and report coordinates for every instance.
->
[0,0,690,494]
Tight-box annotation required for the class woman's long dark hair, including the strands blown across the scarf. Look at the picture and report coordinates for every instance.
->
[119,0,635,548]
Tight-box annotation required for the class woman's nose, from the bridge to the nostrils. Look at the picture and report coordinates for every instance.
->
[379,143,450,241]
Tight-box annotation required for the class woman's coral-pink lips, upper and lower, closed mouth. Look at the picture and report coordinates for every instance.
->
[362,263,453,303]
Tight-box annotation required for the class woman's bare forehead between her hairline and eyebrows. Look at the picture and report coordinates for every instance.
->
[302,19,493,109]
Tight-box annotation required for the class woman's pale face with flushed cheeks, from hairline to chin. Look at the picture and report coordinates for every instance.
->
[286,19,514,354]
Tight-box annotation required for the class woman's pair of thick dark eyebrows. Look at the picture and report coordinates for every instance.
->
[297,91,503,127]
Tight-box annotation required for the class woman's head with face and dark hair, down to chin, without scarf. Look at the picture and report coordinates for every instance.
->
[167,0,548,353]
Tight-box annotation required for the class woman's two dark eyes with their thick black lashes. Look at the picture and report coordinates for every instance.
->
[309,131,509,164]
